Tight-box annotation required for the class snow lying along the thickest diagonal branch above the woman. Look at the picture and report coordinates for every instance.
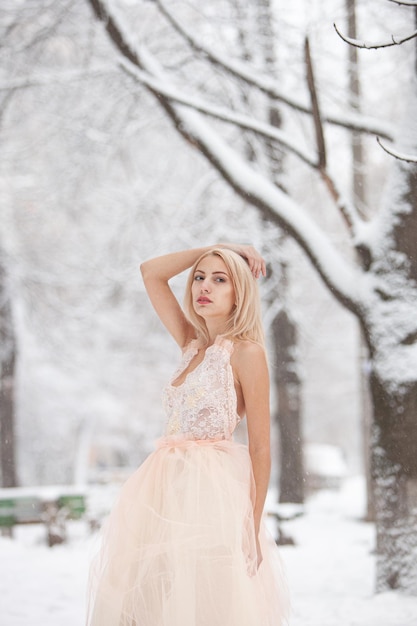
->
[89,0,364,315]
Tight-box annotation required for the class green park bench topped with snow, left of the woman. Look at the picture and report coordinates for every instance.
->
[0,486,86,546]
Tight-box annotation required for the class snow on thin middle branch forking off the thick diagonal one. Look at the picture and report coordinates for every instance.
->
[120,60,318,168]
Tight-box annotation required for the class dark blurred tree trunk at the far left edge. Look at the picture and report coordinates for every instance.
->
[0,266,17,487]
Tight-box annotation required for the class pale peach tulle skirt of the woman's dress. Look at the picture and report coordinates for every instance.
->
[87,439,288,626]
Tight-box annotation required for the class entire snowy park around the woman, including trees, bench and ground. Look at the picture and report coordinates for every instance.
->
[0,0,417,626]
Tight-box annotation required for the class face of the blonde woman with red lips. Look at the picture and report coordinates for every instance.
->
[191,255,235,321]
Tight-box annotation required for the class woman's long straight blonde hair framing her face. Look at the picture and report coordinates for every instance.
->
[184,248,265,347]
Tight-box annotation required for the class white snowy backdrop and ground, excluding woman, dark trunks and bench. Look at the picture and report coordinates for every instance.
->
[0,0,417,626]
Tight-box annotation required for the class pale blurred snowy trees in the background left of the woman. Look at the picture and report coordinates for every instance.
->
[0,0,272,484]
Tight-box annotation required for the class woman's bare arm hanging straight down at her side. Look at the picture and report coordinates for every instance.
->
[236,341,271,558]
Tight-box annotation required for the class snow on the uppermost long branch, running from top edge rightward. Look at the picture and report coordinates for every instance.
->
[155,0,394,141]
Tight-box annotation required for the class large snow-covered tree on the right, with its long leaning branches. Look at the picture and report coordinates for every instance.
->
[84,0,417,593]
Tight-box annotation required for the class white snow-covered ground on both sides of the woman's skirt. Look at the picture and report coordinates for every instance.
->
[0,479,417,626]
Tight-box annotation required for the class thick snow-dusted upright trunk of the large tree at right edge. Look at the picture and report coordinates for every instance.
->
[368,84,417,595]
